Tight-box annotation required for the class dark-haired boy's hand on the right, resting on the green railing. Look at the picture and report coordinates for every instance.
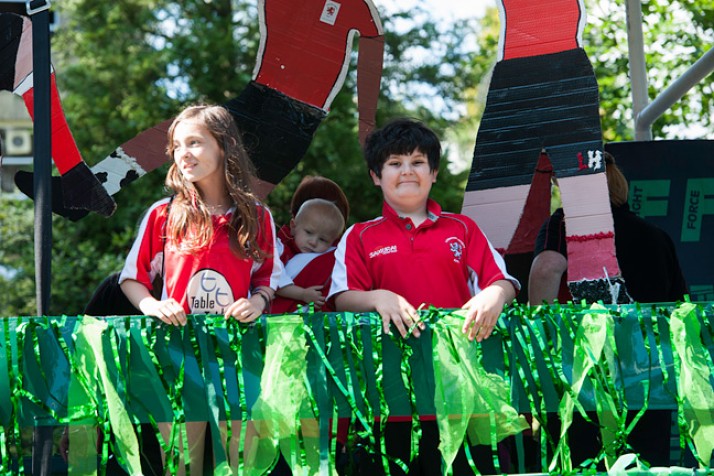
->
[461,280,516,342]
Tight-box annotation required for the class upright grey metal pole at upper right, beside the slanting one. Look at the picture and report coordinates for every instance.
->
[627,0,652,140]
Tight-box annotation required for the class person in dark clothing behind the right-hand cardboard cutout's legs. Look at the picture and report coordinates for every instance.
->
[528,152,688,466]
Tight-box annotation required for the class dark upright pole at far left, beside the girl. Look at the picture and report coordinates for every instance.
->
[27,0,52,316]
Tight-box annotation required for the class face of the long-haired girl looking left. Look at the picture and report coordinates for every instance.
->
[173,120,225,191]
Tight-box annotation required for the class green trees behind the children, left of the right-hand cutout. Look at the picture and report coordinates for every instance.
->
[2,0,469,314]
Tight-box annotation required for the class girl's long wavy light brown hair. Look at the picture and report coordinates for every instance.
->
[165,105,267,260]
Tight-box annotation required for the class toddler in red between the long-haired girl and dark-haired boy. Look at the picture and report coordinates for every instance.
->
[271,198,345,314]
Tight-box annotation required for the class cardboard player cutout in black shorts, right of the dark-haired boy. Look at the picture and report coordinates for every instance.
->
[463,0,629,302]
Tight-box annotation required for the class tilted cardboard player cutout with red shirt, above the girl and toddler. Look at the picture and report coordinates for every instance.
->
[20,0,384,218]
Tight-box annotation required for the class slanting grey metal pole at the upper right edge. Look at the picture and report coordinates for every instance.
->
[635,48,714,138]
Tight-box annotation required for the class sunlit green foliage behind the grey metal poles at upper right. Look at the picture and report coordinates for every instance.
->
[583,0,714,142]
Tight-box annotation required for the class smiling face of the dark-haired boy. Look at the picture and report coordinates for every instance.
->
[370,149,438,213]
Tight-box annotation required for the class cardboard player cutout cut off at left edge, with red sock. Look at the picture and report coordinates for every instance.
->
[0,13,116,216]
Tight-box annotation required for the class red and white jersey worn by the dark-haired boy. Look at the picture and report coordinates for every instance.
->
[329,199,520,309]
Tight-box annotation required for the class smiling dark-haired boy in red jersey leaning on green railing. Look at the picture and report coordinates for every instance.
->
[328,119,520,341]
